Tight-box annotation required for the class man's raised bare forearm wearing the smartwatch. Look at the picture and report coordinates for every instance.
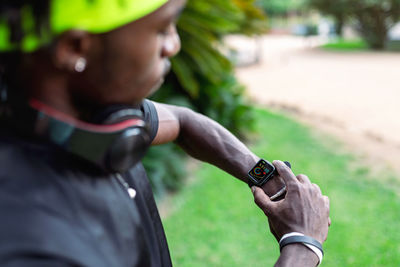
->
[153,100,284,196]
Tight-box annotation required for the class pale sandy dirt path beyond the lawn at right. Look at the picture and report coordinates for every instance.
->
[237,36,400,173]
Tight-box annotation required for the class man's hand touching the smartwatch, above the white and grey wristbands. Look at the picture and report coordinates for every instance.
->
[252,161,330,244]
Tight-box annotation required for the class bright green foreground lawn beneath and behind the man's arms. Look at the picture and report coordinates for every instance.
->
[163,110,400,267]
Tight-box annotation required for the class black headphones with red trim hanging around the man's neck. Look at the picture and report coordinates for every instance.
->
[5,99,151,173]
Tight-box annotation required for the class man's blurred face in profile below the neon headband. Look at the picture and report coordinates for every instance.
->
[72,0,185,105]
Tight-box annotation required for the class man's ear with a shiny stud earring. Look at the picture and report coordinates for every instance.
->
[53,30,93,72]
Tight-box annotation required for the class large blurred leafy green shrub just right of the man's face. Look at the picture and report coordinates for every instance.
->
[154,0,265,134]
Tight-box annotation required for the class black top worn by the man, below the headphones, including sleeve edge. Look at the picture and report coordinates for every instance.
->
[0,102,171,267]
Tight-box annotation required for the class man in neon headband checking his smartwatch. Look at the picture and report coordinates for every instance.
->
[0,0,330,266]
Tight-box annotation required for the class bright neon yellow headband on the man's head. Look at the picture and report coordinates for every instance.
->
[0,0,168,52]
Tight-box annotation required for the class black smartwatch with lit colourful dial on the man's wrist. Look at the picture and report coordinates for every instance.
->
[247,159,291,187]
